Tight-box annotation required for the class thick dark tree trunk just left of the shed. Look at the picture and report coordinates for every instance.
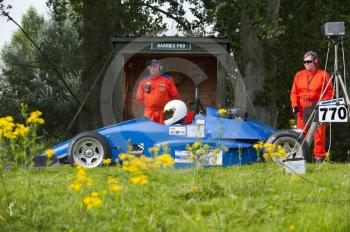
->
[79,0,120,131]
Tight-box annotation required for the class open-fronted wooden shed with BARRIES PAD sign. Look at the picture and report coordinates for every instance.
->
[101,37,230,124]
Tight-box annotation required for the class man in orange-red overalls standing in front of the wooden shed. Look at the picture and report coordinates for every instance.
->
[136,59,179,123]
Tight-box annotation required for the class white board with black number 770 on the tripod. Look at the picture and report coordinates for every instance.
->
[318,105,348,122]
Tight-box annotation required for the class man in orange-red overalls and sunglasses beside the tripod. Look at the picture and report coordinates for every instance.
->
[290,51,333,162]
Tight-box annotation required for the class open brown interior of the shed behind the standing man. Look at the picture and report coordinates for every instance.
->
[123,53,218,120]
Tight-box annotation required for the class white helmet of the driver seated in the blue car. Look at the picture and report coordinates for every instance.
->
[163,100,187,125]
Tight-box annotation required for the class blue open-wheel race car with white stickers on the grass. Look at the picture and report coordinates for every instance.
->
[35,102,307,168]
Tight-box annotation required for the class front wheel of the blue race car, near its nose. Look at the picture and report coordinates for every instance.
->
[68,131,111,168]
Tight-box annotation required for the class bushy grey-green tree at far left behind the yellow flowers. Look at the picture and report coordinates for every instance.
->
[0,8,82,136]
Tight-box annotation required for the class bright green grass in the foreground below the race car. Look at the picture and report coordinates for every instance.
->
[0,163,350,232]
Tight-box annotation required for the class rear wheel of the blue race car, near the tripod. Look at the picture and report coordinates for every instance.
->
[265,130,312,163]
